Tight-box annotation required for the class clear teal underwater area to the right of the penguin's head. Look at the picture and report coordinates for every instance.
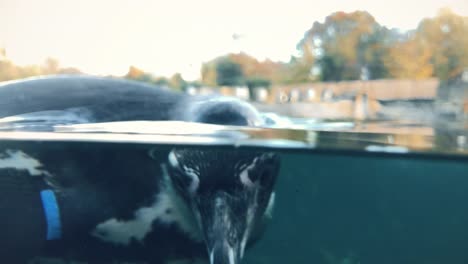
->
[246,153,468,264]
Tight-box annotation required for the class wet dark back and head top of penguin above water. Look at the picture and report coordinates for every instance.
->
[0,76,263,126]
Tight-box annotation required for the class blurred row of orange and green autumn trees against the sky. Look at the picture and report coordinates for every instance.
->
[0,9,468,86]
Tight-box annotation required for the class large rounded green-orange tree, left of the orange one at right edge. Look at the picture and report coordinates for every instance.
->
[297,11,389,81]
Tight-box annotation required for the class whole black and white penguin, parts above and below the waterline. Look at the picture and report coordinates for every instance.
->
[0,76,280,264]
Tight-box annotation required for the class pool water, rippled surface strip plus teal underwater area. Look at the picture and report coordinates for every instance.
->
[0,122,468,264]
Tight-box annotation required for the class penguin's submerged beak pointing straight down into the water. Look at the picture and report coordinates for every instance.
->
[200,193,247,264]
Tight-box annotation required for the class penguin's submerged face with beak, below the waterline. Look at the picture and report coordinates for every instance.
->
[168,149,280,264]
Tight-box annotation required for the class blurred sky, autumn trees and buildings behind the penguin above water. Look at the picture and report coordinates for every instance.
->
[0,0,468,126]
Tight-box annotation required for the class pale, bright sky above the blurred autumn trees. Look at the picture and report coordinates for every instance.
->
[0,0,468,80]
